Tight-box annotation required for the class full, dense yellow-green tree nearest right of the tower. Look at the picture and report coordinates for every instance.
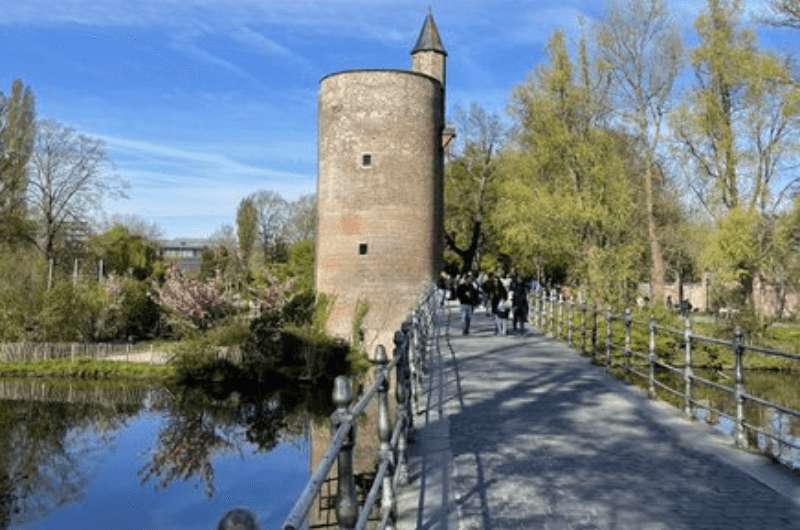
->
[491,31,644,300]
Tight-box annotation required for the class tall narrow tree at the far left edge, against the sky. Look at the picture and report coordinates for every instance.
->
[0,79,35,242]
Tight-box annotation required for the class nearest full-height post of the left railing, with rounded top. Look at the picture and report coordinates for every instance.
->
[333,375,358,530]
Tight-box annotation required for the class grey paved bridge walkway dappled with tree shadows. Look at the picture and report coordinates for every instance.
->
[397,309,800,530]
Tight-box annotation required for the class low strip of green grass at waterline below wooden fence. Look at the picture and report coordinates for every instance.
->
[0,360,175,379]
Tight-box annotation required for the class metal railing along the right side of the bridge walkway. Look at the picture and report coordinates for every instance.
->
[531,289,800,449]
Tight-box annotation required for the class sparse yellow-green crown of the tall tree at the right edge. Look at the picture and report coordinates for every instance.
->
[672,0,800,214]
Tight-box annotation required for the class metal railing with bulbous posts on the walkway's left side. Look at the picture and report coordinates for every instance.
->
[282,286,437,530]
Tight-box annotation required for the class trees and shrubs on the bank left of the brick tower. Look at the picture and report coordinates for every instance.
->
[0,77,362,381]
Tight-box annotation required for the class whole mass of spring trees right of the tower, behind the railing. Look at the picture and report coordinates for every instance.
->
[445,0,800,351]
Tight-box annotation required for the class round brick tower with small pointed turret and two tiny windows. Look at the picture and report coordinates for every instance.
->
[316,13,447,354]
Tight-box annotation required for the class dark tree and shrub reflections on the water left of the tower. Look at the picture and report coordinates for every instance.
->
[0,382,332,529]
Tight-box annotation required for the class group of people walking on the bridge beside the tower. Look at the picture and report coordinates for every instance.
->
[438,272,530,336]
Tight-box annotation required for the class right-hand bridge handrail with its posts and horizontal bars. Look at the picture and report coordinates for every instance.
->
[530,289,800,460]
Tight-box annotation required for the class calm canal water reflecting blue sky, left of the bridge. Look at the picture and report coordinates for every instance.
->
[0,379,332,530]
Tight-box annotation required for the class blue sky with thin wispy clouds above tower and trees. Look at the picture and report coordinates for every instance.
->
[0,0,800,237]
